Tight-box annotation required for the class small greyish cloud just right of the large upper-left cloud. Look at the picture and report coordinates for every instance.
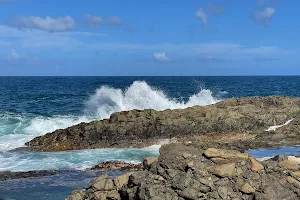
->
[84,14,123,28]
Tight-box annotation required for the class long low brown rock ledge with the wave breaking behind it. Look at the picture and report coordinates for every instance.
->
[26,97,300,151]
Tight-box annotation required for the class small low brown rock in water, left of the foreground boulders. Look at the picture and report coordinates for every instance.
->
[91,160,141,172]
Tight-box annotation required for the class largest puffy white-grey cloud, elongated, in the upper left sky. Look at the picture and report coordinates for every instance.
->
[8,16,75,32]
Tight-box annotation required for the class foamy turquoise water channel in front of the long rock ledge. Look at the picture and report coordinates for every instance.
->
[0,148,159,172]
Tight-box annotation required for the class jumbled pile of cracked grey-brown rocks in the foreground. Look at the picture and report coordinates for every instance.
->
[66,143,300,200]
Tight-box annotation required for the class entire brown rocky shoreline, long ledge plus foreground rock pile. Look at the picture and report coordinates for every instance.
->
[15,96,300,200]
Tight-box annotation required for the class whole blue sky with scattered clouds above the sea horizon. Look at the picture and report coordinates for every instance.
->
[0,0,300,76]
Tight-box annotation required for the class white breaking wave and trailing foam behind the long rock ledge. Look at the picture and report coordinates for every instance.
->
[0,81,219,152]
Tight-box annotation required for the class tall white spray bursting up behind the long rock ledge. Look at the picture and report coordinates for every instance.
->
[85,81,218,119]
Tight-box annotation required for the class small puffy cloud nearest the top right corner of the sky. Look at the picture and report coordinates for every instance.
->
[251,8,276,28]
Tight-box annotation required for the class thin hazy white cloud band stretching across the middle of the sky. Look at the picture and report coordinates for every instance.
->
[0,25,296,59]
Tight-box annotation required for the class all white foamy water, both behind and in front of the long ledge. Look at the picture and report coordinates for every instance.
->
[0,81,220,171]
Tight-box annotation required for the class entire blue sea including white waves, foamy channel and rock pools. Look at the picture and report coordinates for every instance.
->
[0,76,300,200]
